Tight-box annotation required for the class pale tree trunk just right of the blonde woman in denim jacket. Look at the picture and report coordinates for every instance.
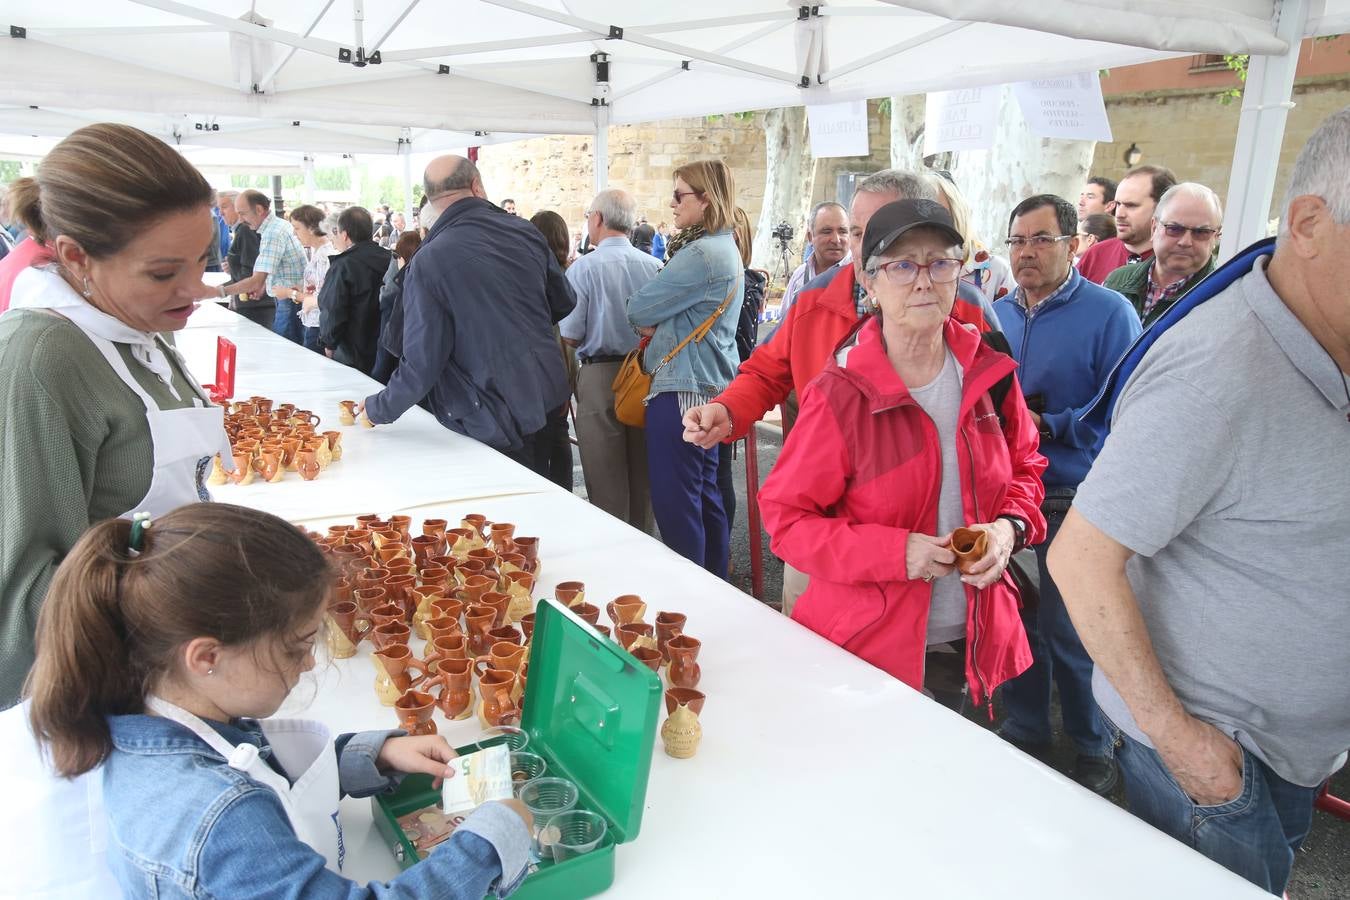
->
[752,107,815,276]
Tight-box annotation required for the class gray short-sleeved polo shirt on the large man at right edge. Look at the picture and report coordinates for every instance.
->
[1073,258,1350,787]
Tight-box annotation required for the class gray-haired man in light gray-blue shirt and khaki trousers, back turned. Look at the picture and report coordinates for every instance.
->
[558,190,660,532]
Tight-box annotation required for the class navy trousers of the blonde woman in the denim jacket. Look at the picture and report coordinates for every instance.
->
[647,391,732,579]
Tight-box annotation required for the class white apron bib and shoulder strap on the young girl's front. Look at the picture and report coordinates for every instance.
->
[146,696,346,872]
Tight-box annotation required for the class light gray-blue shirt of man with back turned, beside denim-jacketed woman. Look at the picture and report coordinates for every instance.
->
[558,237,662,359]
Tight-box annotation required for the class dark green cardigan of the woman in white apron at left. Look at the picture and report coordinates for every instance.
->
[0,309,194,708]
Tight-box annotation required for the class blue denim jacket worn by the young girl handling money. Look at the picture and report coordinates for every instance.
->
[103,715,529,900]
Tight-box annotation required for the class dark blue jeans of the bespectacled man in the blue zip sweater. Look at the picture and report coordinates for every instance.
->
[1003,515,1108,756]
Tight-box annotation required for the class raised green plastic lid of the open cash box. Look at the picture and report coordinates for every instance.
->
[521,599,662,842]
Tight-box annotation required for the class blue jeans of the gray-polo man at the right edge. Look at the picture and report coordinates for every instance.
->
[1111,726,1318,896]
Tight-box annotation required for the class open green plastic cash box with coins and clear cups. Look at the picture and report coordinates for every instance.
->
[371,599,662,900]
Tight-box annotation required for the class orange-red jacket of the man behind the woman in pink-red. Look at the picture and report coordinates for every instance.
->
[713,266,987,441]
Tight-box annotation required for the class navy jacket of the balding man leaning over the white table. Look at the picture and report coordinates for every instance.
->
[366,197,576,451]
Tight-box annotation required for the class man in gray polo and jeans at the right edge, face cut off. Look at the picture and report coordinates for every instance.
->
[1049,108,1350,895]
